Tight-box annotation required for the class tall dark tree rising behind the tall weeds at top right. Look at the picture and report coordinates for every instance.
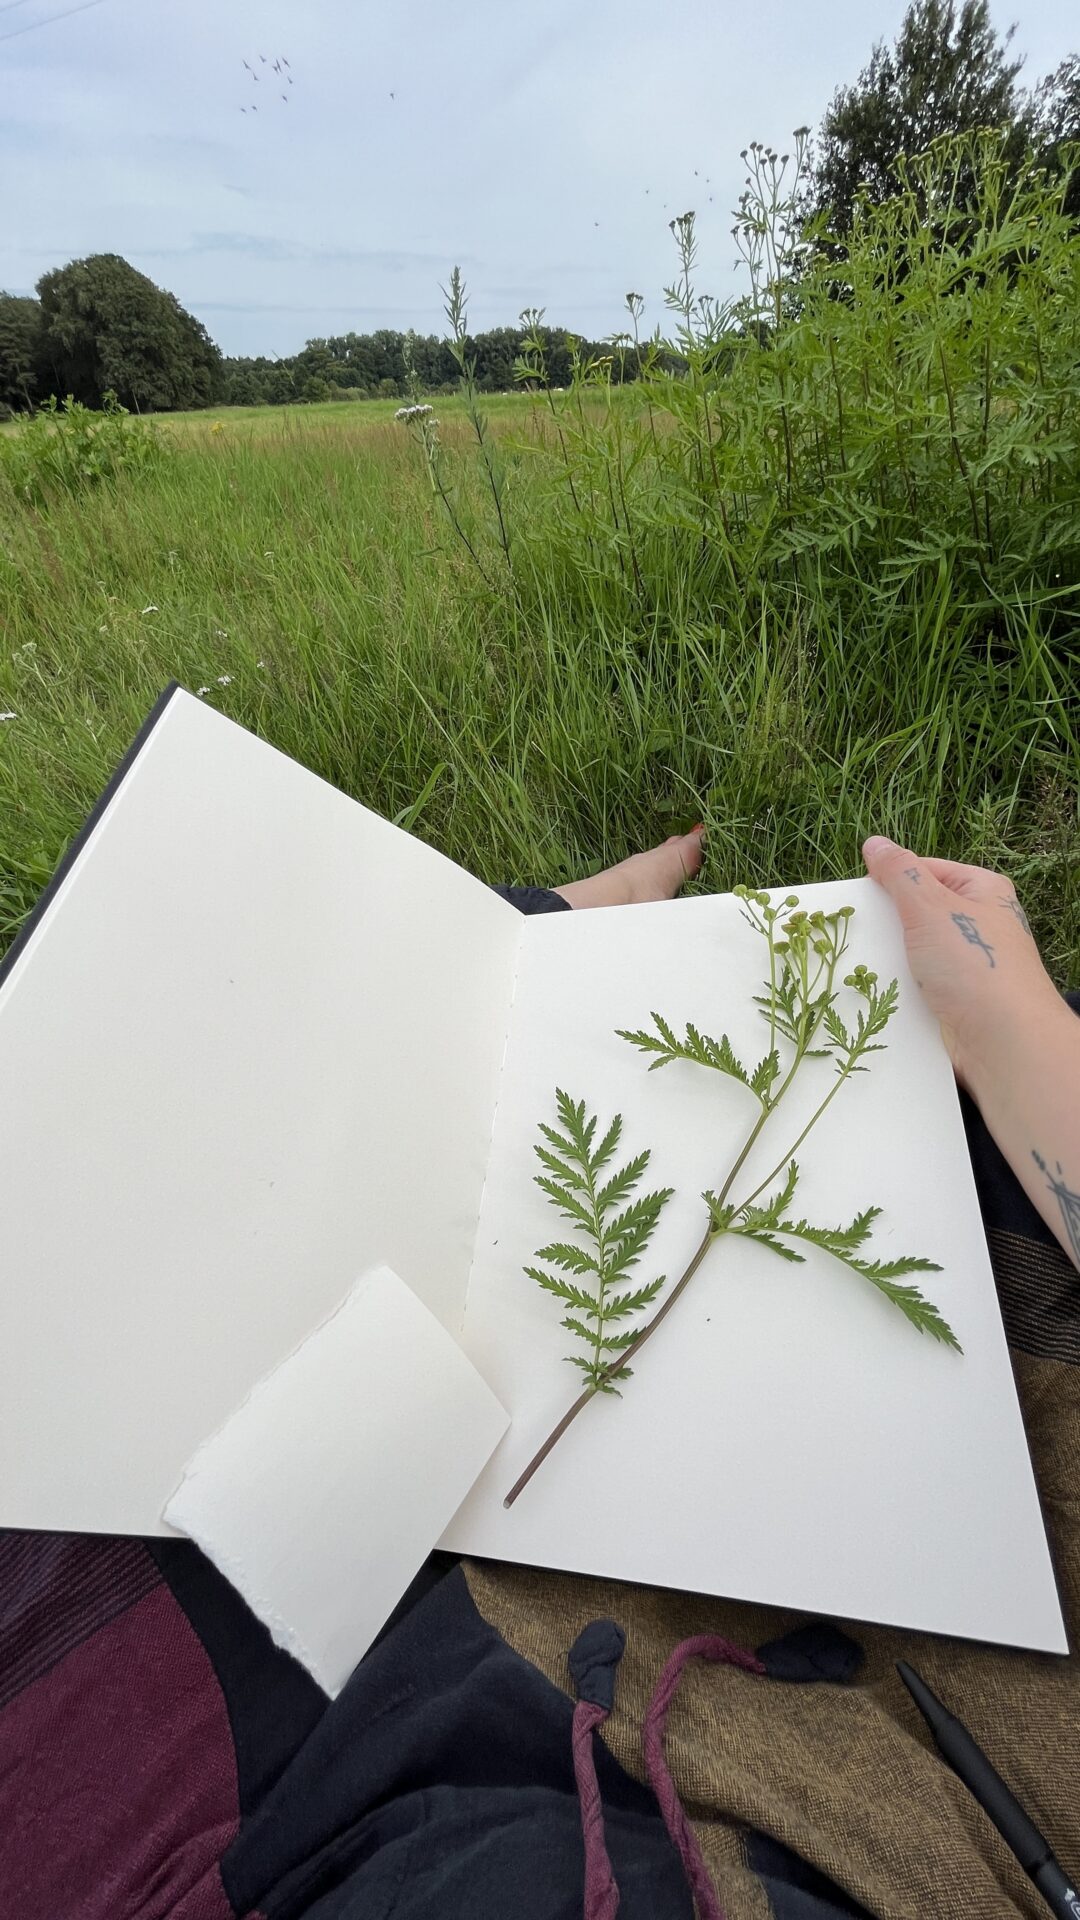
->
[809,0,1026,234]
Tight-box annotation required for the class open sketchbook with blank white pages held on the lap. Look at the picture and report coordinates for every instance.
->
[0,689,1065,1651]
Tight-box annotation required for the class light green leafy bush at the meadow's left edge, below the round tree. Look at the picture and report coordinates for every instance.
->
[0,394,167,507]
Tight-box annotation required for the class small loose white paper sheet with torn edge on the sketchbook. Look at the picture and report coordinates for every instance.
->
[165,1267,507,1695]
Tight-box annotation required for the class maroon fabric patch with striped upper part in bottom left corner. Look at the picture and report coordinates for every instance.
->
[0,1559,245,1920]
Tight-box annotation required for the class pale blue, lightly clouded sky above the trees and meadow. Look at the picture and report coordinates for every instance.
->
[0,0,1080,355]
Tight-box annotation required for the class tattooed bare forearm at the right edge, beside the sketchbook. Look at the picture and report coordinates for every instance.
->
[969,995,1080,1267]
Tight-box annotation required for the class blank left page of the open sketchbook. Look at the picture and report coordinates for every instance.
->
[0,693,521,1534]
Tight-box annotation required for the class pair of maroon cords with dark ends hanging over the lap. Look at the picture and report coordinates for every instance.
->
[569,1620,767,1920]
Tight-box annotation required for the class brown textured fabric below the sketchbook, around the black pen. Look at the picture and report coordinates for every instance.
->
[467,1213,1080,1920]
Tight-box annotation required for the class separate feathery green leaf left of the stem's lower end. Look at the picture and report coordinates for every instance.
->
[525,1087,673,1394]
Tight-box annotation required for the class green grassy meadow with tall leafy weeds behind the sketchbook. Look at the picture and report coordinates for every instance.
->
[0,142,1080,985]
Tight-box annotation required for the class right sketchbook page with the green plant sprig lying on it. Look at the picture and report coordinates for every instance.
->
[442,879,1067,1651]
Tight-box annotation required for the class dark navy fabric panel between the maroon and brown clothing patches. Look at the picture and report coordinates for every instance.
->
[221,1569,692,1920]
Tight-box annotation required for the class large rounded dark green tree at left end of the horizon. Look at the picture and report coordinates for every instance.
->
[38,253,223,411]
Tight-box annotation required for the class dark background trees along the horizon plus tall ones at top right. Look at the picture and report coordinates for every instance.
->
[0,0,1080,413]
